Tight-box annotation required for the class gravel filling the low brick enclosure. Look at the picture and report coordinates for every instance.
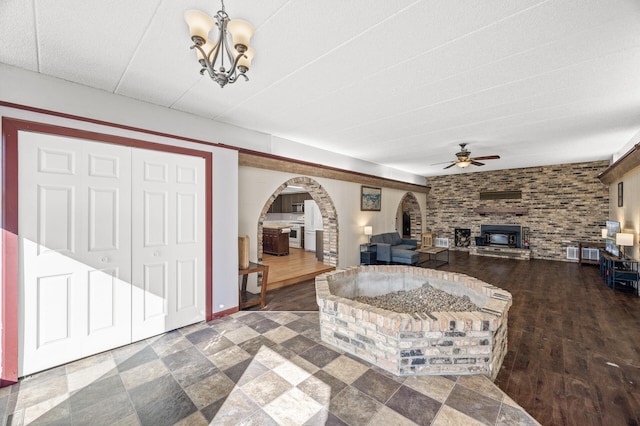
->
[354,284,480,314]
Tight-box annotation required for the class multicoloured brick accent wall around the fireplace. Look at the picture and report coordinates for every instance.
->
[425,161,609,260]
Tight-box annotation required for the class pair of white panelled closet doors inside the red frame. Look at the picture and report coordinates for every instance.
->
[18,131,205,376]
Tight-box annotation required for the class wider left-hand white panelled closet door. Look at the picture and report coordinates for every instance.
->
[18,132,131,376]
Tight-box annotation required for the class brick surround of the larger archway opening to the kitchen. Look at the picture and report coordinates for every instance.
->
[256,176,338,267]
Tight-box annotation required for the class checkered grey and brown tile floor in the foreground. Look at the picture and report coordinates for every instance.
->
[0,311,538,426]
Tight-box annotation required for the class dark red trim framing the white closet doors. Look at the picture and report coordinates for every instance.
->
[0,117,213,387]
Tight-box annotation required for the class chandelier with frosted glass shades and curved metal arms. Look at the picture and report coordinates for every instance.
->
[184,0,255,87]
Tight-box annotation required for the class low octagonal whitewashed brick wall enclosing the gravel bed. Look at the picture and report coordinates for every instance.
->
[316,265,511,380]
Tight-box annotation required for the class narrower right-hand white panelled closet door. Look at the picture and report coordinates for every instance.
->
[132,150,206,341]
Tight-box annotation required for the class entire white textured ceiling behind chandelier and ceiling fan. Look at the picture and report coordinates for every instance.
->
[0,0,640,176]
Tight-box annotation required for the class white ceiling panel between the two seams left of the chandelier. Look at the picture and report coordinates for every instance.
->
[36,0,161,91]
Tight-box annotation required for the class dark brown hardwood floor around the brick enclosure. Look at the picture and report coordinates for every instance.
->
[251,251,640,426]
